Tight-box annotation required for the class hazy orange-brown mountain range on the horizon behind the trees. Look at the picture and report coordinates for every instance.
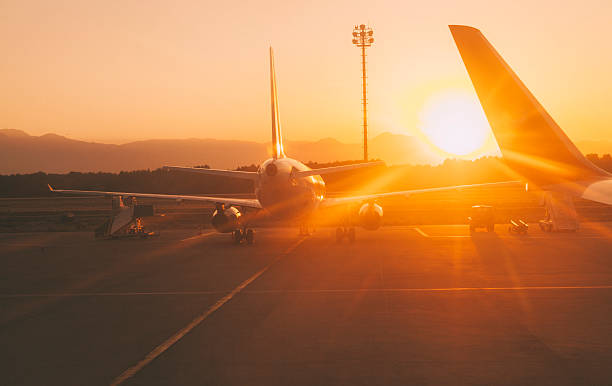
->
[0,129,612,174]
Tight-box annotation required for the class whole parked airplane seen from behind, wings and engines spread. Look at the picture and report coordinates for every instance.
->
[48,47,516,244]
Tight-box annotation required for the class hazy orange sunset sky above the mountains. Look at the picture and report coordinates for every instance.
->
[0,0,612,157]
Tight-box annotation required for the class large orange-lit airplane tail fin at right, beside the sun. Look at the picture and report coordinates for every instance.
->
[449,25,609,186]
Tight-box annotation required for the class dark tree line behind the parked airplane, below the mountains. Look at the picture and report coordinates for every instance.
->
[0,154,612,197]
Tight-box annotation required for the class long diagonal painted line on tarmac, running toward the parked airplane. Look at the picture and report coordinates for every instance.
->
[111,237,306,386]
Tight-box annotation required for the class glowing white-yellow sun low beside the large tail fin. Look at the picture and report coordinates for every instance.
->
[419,90,491,156]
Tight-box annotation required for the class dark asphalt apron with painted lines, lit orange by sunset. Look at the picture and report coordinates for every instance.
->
[0,223,612,385]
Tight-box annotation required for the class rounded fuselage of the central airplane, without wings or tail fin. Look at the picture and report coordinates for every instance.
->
[255,158,325,218]
